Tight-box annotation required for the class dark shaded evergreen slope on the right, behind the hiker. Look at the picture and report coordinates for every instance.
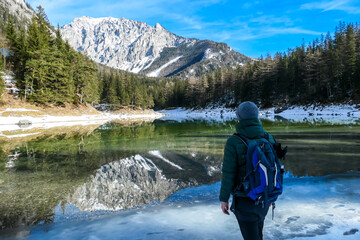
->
[162,22,360,107]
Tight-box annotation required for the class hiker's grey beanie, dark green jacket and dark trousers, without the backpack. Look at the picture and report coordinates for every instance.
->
[219,102,275,240]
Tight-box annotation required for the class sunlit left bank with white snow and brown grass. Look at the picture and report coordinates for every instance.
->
[0,72,165,138]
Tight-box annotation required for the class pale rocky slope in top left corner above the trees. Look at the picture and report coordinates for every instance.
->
[0,0,35,21]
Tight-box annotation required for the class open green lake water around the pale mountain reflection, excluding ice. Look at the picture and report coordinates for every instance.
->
[0,120,360,229]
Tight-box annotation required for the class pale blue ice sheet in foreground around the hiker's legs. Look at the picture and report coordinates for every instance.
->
[16,173,360,240]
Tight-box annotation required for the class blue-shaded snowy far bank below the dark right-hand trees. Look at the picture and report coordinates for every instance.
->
[159,104,360,124]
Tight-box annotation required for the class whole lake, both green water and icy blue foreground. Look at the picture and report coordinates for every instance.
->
[0,119,360,239]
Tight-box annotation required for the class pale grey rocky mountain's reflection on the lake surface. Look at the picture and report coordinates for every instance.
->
[68,153,220,211]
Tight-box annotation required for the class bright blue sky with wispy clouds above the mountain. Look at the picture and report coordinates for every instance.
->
[27,0,360,57]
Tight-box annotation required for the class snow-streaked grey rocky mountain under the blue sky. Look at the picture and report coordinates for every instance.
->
[61,17,251,77]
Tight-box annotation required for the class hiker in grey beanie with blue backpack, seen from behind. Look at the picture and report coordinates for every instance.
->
[219,101,287,240]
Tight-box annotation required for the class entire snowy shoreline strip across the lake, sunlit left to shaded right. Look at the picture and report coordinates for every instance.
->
[0,104,360,139]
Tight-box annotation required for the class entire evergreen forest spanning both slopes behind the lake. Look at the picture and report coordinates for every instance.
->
[0,6,360,109]
